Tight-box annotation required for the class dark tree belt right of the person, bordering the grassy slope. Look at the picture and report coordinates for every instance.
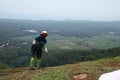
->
[41,47,120,67]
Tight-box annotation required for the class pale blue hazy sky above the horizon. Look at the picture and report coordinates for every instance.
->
[0,0,120,21]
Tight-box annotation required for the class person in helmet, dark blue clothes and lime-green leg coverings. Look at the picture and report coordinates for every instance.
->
[30,31,48,70]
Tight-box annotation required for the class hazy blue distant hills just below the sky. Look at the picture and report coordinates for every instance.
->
[0,19,120,38]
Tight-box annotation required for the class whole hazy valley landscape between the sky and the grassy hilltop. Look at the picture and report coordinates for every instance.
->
[0,19,120,67]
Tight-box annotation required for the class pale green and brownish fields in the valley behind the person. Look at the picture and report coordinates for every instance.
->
[13,34,120,50]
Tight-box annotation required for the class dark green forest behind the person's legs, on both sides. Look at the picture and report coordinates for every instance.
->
[0,47,120,67]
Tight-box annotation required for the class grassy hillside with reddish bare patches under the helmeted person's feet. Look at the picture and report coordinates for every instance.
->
[0,56,120,80]
